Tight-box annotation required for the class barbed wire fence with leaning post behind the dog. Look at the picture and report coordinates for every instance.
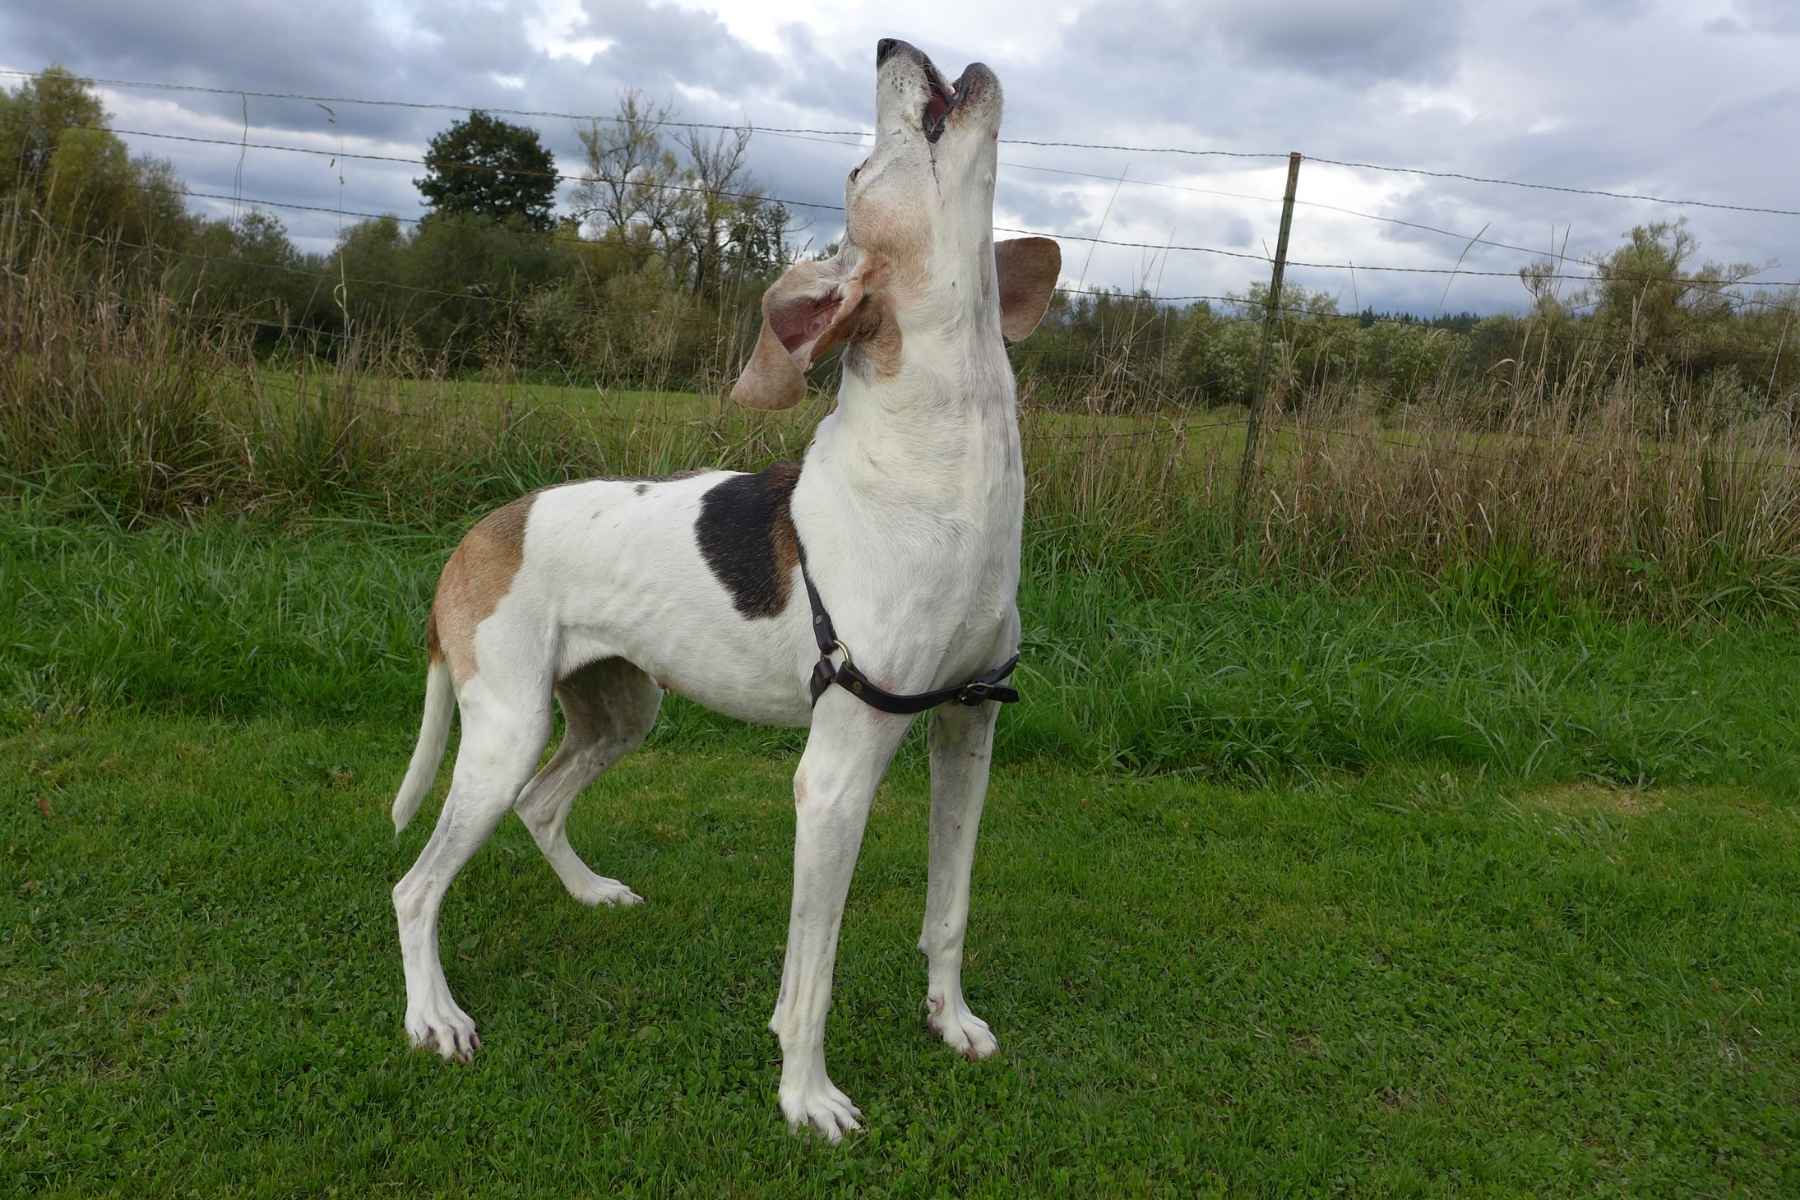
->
[0,70,1800,500]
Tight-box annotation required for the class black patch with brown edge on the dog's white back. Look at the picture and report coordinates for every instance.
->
[693,462,799,617]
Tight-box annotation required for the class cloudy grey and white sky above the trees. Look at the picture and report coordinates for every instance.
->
[0,0,1800,313]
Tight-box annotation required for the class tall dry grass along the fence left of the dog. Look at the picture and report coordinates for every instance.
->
[0,209,817,522]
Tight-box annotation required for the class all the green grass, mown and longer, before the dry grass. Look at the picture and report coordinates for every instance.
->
[0,497,1800,1196]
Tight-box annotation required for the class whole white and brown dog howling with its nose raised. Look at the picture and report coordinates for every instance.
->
[381,40,1060,1141]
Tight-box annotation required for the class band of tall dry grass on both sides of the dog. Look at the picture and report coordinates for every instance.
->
[0,214,1800,615]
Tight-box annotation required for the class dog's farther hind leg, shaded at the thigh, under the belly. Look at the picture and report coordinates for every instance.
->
[513,658,662,905]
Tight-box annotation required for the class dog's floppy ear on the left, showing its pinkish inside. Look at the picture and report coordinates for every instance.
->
[731,255,862,408]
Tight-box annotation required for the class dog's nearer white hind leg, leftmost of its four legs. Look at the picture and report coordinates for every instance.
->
[394,676,551,1061]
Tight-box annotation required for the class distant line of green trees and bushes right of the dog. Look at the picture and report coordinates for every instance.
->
[1015,221,1800,425]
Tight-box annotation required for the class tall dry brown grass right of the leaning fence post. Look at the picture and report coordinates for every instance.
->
[1251,307,1800,613]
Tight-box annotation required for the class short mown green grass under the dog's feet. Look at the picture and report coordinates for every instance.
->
[0,714,1800,1196]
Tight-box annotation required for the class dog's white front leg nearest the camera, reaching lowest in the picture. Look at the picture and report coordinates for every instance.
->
[769,687,911,1142]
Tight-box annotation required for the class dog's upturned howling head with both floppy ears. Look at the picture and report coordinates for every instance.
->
[731,38,1062,408]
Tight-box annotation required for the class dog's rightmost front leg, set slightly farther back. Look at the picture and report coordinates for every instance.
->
[918,703,1001,1060]
